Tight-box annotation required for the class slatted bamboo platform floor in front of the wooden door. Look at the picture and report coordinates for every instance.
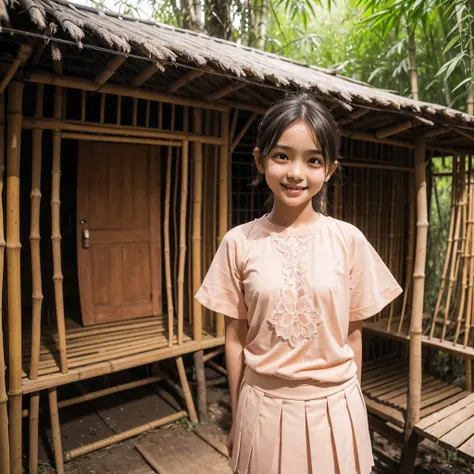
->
[22,315,224,393]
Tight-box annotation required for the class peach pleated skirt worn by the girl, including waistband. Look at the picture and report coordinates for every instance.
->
[231,372,374,474]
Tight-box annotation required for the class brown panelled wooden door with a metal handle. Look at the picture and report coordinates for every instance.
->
[77,141,161,325]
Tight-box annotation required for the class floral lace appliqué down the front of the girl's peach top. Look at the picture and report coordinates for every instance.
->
[268,234,321,347]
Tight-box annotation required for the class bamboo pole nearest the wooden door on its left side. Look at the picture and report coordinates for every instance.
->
[51,82,68,373]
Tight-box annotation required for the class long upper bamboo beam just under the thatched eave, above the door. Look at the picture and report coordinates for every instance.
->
[26,73,228,112]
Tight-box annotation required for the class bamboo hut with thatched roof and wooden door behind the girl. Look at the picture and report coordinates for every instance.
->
[0,0,474,474]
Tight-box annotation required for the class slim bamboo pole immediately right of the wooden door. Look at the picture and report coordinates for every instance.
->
[163,147,174,347]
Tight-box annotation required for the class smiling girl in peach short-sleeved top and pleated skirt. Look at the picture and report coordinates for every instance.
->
[196,94,402,474]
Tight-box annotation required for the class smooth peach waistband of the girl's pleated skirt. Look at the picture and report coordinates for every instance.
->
[243,366,358,400]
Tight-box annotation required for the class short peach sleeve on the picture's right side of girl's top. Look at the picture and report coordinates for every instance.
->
[349,231,402,321]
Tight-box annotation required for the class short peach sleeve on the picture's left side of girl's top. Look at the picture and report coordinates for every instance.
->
[195,234,247,319]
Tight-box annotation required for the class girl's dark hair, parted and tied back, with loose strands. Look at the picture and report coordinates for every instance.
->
[252,93,341,214]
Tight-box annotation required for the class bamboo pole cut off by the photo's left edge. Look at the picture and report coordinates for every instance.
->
[0,92,10,474]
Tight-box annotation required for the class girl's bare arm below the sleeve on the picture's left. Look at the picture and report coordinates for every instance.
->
[225,316,249,421]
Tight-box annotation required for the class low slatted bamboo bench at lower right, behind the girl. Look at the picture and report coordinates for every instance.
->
[362,356,474,461]
